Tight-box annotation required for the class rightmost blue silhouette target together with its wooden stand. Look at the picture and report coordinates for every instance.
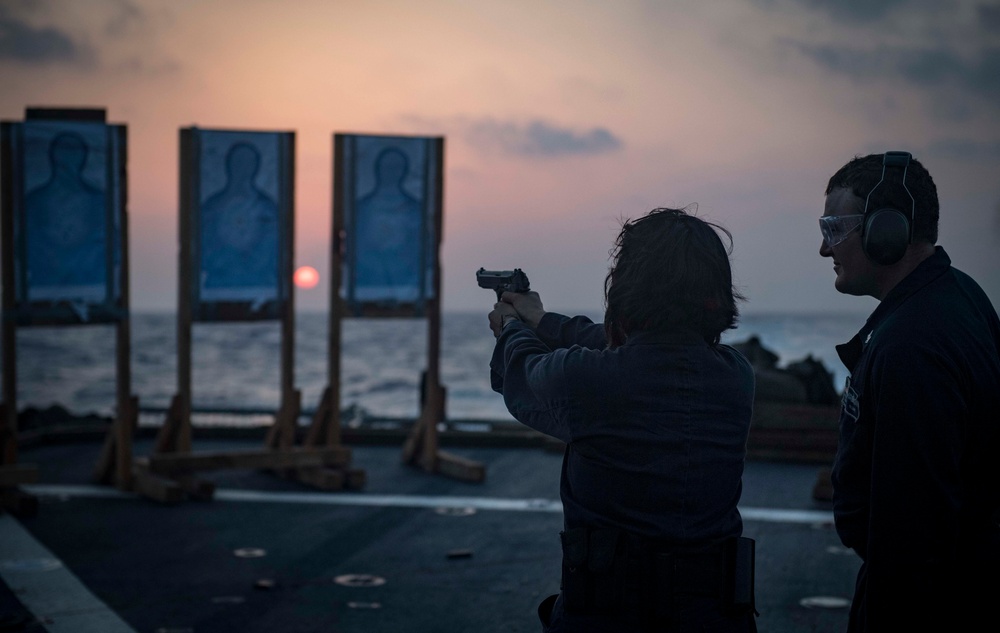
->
[307,133,485,482]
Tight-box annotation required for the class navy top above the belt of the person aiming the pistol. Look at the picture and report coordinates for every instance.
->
[490,313,754,544]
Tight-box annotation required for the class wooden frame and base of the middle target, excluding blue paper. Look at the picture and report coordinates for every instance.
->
[135,128,365,503]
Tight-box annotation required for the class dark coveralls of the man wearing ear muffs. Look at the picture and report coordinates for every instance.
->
[832,246,1000,633]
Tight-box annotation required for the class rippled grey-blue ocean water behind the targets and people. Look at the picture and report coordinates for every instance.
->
[1,312,865,425]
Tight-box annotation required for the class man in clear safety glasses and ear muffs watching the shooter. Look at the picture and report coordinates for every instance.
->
[819,151,1000,633]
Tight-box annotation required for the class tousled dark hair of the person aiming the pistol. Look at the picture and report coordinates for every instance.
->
[604,208,746,348]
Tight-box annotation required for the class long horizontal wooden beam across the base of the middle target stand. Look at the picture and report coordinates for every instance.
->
[149,447,351,475]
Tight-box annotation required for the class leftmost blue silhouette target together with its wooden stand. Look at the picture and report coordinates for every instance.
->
[0,108,139,512]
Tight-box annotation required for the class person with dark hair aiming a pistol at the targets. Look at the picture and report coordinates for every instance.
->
[477,208,757,633]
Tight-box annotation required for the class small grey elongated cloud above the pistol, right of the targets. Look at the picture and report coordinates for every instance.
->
[462,118,622,157]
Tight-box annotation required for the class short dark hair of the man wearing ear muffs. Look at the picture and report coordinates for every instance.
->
[825,154,941,244]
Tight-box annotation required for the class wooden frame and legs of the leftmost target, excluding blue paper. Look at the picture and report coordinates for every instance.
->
[0,108,139,515]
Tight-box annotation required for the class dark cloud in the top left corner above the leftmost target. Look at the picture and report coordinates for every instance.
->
[0,7,94,65]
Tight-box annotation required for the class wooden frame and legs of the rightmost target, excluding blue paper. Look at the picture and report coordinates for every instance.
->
[330,134,486,483]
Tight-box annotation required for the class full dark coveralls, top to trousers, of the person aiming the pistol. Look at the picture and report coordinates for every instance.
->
[490,313,756,633]
